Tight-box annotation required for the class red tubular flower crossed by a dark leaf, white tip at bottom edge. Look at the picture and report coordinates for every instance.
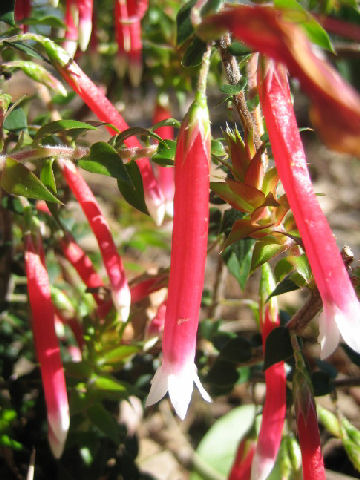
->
[251,264,286,480]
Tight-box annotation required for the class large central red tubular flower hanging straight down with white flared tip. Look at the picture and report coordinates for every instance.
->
[146,92,211,418]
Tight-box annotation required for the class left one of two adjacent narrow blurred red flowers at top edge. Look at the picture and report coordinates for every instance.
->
[115,0,130,77]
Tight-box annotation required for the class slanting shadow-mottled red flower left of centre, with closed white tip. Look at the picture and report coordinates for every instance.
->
[59,159,130,322]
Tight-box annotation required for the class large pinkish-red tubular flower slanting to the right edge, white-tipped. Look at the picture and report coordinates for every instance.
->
[259,63,360,358]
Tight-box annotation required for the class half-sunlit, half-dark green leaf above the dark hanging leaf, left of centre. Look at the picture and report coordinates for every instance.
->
[78,142,131,184]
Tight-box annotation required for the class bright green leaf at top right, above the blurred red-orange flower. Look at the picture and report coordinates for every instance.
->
[274,0,335,53]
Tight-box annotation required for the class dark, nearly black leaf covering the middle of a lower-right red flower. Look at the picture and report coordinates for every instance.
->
[264,327,293,370]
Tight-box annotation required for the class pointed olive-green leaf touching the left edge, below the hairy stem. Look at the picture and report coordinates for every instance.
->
[1,158,61,203]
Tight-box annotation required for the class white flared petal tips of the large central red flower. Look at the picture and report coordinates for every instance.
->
[145,361,211,420]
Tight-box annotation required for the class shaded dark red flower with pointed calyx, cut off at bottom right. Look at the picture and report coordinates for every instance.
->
[292,337,326,480]
